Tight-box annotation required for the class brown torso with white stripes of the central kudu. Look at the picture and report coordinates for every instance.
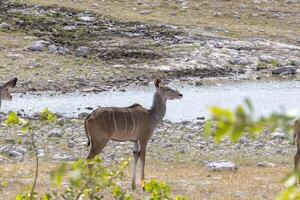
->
[85,104,153,141]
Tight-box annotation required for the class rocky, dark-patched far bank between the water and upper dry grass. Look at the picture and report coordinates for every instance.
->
[0,2,300,91]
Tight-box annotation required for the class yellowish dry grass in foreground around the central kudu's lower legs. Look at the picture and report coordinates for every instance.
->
[0,159,291,200]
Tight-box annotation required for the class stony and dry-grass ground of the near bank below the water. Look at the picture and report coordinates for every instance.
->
[0,115,295,199]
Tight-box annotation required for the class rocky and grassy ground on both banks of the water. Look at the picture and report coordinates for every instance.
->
[0,0,300,199]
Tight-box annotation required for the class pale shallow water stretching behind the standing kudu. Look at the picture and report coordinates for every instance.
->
[1,81,300,122]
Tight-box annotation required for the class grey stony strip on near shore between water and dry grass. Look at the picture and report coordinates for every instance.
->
[0,116,294,164]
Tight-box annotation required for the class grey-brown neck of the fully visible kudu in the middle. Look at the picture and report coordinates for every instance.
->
[150,91,167,126]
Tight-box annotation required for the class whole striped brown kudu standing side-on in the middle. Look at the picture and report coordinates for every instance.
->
[84,79,182,189]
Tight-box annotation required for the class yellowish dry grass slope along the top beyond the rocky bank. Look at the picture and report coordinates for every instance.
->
[24,0,300,43]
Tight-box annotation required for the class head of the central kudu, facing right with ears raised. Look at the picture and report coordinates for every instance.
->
[154,79,183,100]
